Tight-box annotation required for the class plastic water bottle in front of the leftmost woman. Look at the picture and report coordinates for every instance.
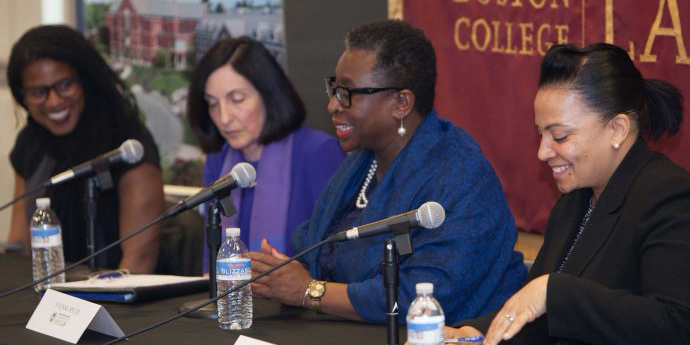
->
[29,198,65,292]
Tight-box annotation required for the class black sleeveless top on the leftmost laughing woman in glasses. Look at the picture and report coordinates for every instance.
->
[10,116,160,268]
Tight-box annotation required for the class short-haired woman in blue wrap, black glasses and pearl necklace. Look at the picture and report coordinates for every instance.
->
[250,20,525,323]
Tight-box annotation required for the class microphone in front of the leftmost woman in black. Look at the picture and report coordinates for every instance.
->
[43,139,144,187]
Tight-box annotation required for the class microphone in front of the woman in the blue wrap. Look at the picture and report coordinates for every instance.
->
[329,201,446,242]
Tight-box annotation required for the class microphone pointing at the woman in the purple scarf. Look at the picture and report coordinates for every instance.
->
[161,163,256,219]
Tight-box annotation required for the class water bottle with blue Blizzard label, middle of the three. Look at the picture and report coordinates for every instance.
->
[216,228,253,330]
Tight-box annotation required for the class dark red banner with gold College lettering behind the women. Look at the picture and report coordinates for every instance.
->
[403,0,690,232]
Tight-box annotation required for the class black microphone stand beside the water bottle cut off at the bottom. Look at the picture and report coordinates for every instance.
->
[381,222,413,345]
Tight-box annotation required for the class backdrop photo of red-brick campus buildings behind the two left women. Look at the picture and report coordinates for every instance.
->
[80,0,286,186]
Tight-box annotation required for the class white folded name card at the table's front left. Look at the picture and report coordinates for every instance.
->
[26,289,125,344]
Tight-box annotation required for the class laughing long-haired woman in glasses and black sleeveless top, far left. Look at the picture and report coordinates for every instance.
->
[7,26,163,273]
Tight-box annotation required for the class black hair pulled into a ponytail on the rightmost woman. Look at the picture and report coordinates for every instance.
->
[539,43,683,141]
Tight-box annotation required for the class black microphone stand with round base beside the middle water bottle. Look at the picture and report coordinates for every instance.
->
[180,197,237,319]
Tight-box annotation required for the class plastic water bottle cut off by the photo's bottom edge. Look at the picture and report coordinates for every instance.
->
[407,283,446,345]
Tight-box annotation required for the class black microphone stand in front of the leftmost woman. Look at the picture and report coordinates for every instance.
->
[84,159,113,272]
